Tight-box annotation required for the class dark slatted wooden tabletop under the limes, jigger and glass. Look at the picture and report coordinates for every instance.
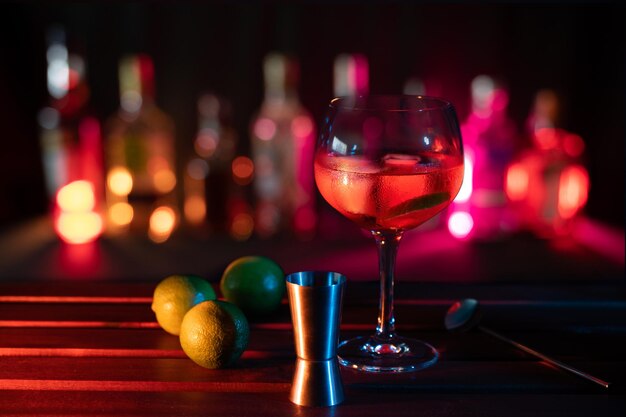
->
[0,281,626,417]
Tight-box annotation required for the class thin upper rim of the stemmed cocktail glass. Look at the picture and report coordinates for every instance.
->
[328,94,454,113]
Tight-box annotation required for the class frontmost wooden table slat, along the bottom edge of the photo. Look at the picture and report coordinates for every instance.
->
[0,387,626,417]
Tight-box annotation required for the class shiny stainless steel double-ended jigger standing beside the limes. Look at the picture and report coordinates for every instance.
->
[286,272,346,406]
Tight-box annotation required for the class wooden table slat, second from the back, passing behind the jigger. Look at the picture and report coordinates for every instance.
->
[0,301,626,333]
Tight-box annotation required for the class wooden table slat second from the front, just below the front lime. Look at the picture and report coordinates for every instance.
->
[0,357,626,393]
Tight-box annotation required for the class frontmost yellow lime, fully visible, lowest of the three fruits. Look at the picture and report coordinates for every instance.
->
[180,301,250,369]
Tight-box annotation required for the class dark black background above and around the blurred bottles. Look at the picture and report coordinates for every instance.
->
[0,2,626,231]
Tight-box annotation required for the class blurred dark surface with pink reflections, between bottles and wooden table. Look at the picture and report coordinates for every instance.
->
[0,213,625,282]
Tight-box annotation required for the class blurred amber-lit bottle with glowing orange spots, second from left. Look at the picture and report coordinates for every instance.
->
[106,55,179,243]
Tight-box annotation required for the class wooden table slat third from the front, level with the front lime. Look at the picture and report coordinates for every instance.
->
[0,327,623,361]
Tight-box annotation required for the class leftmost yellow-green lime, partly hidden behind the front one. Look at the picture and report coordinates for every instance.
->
[152,275,217,335]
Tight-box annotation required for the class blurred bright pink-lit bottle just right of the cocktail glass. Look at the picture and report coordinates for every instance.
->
[448,75,519,240]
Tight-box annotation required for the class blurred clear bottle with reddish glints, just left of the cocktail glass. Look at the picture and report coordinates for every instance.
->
[251,53,317,239]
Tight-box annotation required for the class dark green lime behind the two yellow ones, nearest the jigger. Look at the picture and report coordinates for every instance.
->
[220,256,285,314]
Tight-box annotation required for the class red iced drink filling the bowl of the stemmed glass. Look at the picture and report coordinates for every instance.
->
[315,150,463,230]
